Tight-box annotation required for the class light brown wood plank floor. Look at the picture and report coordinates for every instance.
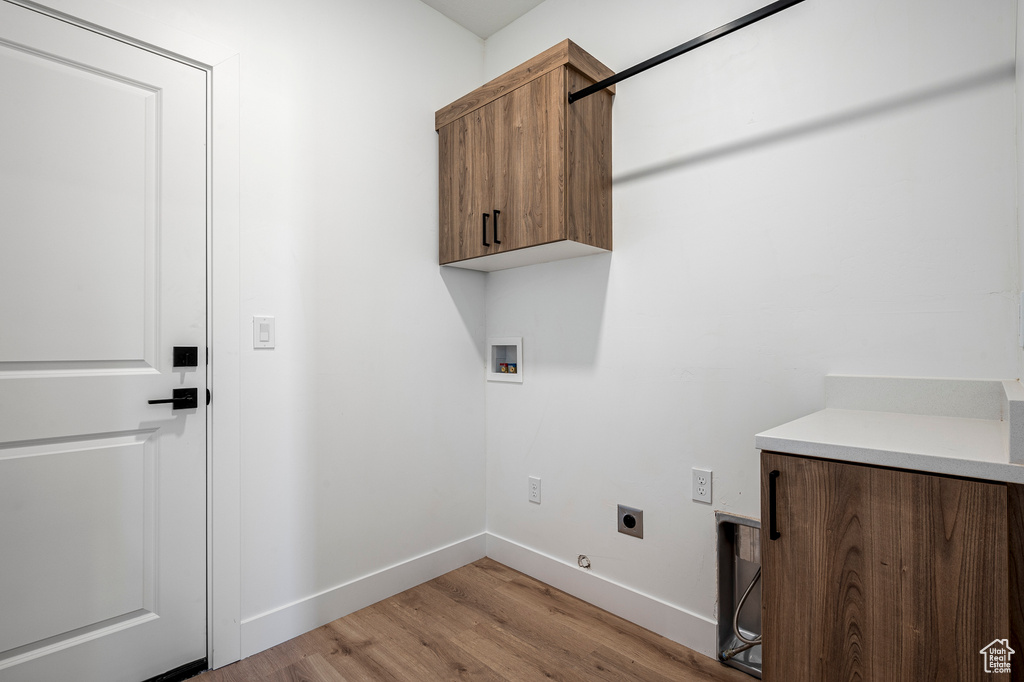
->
[194,558,754,682]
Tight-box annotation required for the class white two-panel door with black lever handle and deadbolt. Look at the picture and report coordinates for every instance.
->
[0,0,207,682]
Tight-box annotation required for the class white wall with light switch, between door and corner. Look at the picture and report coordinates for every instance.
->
[76,0,484,653]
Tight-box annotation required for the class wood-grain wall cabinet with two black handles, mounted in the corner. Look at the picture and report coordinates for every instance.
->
[435,40,613,270]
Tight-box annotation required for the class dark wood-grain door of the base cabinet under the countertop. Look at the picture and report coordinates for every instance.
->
[761,453,1016,682]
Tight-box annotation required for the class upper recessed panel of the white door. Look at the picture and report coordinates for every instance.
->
[0,38,157,363]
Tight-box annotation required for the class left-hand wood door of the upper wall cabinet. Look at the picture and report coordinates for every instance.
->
[437,102,495,264]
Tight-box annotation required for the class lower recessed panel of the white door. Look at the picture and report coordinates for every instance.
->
[0,432,149,651]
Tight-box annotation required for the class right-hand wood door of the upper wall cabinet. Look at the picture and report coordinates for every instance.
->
[488,69,567,251]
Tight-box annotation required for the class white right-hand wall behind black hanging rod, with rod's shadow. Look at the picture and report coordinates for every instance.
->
[484,0,1020,648]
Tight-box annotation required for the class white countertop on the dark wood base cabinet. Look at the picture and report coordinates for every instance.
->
[755,374,1024,483]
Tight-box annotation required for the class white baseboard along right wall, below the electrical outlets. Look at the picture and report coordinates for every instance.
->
[486,534,718,658]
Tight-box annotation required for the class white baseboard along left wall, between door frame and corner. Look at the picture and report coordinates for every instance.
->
[242,532,486,658]
